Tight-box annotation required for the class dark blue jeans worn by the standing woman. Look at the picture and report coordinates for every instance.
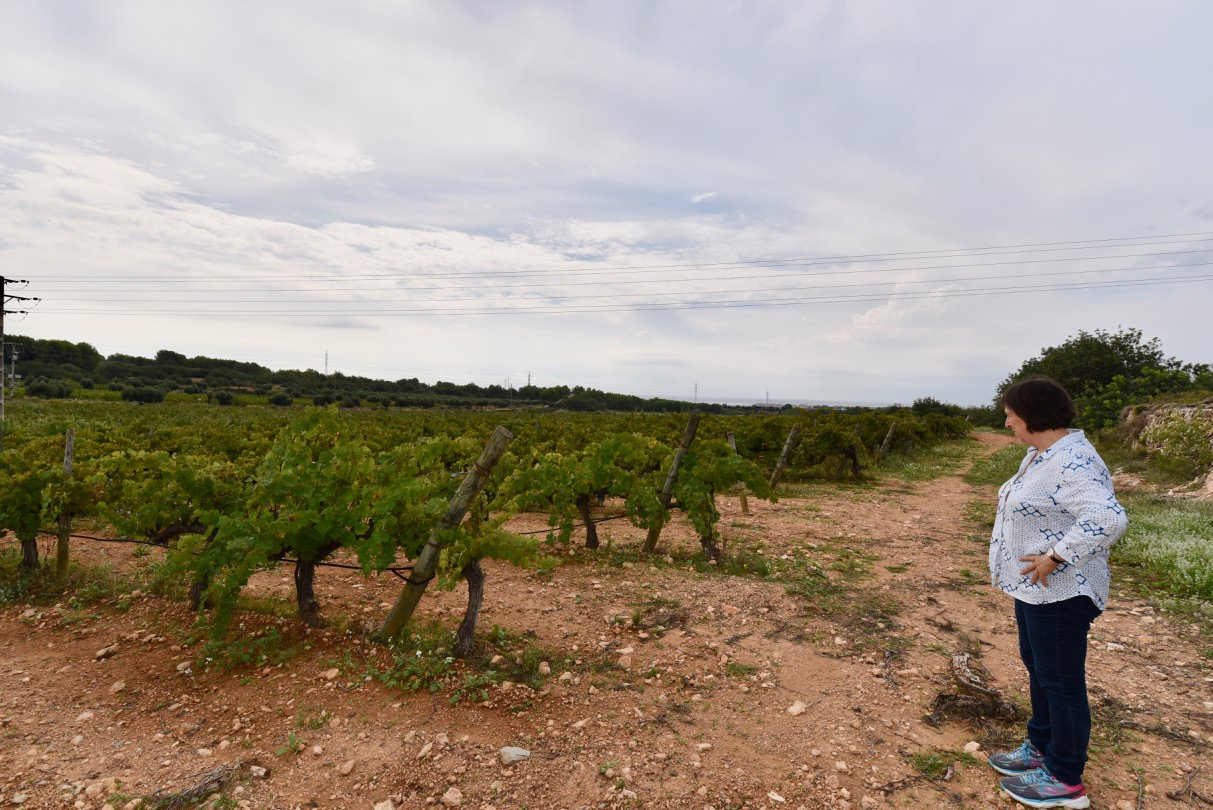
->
[1015,597,1100,785]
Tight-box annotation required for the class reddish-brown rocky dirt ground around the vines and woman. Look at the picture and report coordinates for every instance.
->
[0,434,1213,810]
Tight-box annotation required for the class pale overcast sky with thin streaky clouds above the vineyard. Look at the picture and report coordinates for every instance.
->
[0,0,1213,404]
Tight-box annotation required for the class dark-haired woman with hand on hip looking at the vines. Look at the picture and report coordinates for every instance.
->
[990,378,1127,808]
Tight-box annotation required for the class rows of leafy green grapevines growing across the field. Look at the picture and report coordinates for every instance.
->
[0,403,966,651]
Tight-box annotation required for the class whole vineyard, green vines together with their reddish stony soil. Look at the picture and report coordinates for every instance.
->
[0,401,1213,810]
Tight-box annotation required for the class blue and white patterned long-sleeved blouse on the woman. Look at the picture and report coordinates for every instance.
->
[990,430,1128,610]
